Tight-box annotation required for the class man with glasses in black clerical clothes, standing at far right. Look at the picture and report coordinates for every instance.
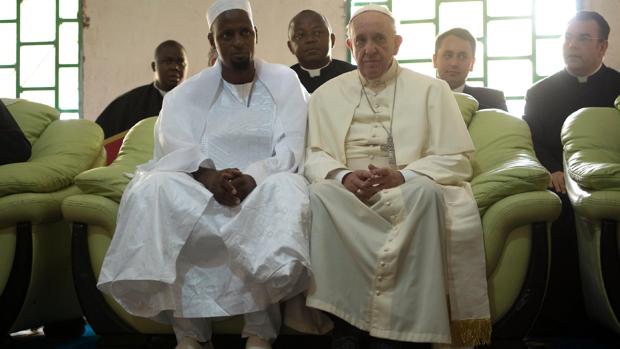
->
[523,11,620,336]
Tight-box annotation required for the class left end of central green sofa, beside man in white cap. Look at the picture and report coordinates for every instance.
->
[62,117,172,335]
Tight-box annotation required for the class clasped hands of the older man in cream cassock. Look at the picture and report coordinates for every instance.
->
[342,164,405,203]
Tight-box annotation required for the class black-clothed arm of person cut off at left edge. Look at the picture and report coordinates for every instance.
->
[0,100,32,165]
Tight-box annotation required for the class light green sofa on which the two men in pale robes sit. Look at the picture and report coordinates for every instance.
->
[63,95,560,338]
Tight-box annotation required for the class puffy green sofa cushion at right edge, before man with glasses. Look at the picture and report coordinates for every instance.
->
[562,108,620,191]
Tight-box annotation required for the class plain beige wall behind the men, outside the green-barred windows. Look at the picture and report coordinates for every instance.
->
[83,0,620,120]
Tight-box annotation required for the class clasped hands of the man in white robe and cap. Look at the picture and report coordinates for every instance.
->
[192,168,256,206]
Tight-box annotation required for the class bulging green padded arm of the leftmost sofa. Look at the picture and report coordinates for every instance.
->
[0,120,103,196]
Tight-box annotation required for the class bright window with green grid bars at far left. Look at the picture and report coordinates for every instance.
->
[0,0,82,119]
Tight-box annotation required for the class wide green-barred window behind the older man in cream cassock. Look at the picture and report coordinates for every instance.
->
[348,0,580,117]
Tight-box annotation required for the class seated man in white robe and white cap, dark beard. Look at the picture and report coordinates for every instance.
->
[99,0,310,348]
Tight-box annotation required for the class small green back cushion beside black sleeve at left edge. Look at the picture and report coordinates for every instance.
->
[7,99,60,144]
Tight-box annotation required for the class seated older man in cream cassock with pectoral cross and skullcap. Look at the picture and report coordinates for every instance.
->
[304,5,491,349]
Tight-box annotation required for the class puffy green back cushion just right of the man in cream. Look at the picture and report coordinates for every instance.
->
[469,110,549,214]
